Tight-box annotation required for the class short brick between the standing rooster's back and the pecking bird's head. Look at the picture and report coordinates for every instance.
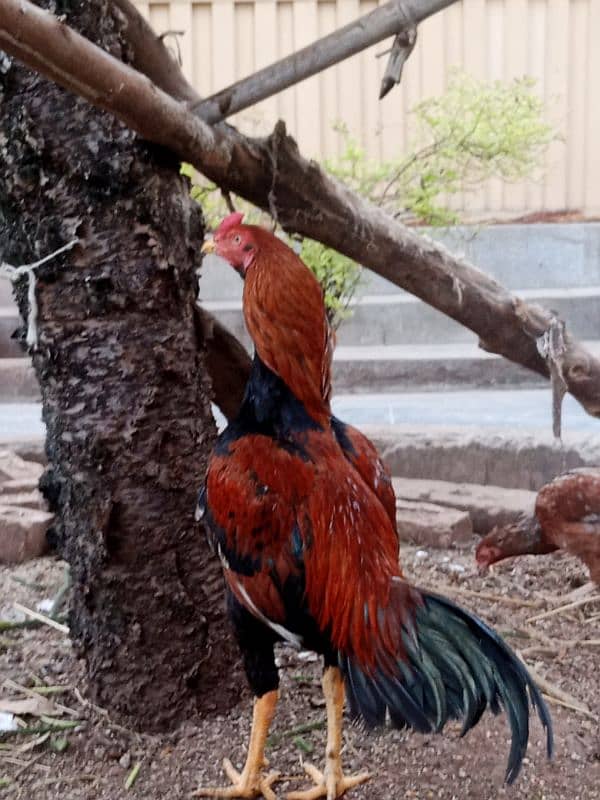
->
[396,500,473,547]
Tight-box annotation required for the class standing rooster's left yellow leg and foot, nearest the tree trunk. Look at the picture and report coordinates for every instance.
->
[194,689,279,800]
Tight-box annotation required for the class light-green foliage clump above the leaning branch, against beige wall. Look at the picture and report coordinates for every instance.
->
[325,71,556,225]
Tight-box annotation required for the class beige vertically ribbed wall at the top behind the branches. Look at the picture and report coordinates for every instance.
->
[136,0,600,216]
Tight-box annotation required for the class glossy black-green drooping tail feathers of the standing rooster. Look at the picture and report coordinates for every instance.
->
[339,578,553,783]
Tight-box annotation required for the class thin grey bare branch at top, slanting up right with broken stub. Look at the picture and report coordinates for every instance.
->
[192,0,456,123]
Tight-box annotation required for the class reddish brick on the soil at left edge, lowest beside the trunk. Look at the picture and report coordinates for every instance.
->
[0,505,54,564]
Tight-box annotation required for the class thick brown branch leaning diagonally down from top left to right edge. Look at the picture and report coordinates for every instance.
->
[0,0,600,417]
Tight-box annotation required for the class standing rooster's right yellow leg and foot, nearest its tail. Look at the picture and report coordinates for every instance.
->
[287,667,371,800]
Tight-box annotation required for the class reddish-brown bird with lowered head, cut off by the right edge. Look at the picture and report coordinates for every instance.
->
[475,468,600,588]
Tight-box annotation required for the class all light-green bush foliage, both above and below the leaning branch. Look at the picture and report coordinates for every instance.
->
[181,71,556,316]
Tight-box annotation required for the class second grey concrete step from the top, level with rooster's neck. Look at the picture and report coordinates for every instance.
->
[203,286,600,348]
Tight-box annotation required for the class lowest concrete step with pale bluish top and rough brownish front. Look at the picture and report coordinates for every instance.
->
[0,398,600,490]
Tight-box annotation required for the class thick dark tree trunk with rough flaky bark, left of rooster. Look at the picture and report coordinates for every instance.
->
[0,0,239,729]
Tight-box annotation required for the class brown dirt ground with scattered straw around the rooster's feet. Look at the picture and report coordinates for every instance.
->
[0,547,600,800]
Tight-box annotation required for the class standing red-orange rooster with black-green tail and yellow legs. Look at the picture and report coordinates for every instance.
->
[196,214,552,800]
